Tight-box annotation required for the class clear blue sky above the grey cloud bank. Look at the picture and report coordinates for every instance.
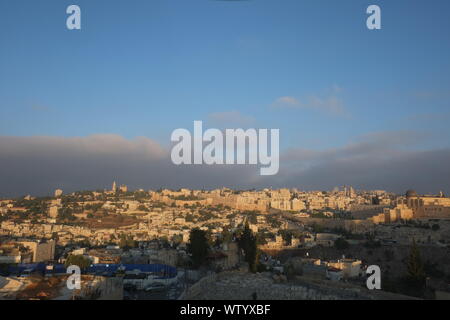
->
[0,0,450,194]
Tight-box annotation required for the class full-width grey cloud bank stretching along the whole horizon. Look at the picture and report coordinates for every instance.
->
[0,131,450,197]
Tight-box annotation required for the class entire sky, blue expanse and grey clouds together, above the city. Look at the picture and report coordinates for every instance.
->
[0,0,450,196]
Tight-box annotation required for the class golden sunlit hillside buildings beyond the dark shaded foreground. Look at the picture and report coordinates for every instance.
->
[0,182,450,298]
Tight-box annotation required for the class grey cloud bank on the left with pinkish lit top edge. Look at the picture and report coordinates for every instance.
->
[0,134,259,197]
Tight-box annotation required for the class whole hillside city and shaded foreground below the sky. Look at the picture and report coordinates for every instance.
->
[0,181,450,301]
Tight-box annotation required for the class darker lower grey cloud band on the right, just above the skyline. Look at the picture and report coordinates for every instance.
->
[277,149,450,194]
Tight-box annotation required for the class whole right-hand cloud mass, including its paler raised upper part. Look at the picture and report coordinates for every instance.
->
[270,131,450,193]
